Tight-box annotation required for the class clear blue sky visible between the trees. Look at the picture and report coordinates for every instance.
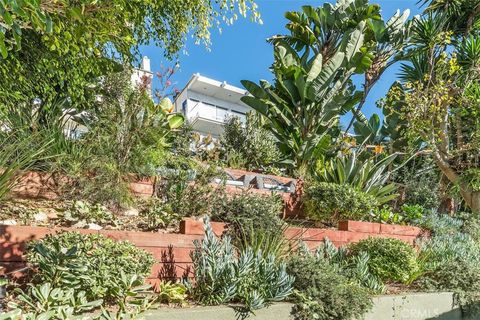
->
[141,0,420,125]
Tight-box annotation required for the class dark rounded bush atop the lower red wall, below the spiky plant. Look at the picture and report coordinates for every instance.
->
[304,182,379,224]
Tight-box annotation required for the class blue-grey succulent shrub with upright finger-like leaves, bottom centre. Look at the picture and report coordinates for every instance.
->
[188,219,294,311]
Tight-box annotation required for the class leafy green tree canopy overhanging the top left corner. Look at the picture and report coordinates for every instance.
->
[0,0,260,124]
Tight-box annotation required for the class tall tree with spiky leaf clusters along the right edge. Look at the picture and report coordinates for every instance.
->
[402,0,480,213]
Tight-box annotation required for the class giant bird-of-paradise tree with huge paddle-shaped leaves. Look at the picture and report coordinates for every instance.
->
[243,0,408,174]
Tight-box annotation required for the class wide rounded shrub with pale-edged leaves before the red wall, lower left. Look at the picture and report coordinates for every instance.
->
[27,232,154,302]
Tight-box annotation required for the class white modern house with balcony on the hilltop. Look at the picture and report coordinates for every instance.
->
[174,73,252,138]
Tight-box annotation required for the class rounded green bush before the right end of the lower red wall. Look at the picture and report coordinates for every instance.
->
[348,238,418,283]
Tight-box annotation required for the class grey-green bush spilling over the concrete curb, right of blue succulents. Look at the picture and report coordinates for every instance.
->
[287,255,372,320]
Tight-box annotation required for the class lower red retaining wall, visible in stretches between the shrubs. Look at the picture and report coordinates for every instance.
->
[0,219,426,284]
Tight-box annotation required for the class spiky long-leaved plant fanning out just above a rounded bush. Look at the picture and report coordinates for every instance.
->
[315,152,397,204]
